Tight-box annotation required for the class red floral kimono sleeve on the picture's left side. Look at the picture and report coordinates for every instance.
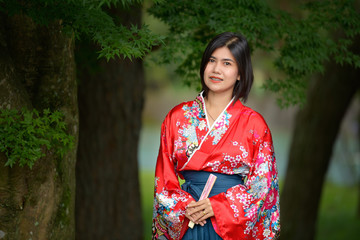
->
[152,113,194,239]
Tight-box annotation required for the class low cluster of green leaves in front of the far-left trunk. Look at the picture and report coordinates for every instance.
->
[0,109,74,168]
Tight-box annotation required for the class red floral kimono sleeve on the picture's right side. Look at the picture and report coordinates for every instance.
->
[210,121,280,240]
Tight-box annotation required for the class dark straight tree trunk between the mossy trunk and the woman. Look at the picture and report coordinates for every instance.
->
[76,3,143,240]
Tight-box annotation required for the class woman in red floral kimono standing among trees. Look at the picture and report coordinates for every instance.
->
[153,32,280,240]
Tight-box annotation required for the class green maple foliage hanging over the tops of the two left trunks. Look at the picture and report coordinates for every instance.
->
[0,0,162,60]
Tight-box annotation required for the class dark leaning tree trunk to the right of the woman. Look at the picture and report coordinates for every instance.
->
[281,48,360,240]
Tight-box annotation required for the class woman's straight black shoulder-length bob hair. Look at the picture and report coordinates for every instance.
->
[200,32,254,102]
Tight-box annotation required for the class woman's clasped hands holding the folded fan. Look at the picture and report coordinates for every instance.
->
[185,198,214,226]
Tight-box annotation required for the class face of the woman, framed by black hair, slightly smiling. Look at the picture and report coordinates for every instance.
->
[204,47,240,98]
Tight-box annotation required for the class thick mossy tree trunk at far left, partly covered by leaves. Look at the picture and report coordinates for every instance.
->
[0,13,78,240]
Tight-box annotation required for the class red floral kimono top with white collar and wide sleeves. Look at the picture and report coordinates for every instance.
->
[153,94,280,240]
